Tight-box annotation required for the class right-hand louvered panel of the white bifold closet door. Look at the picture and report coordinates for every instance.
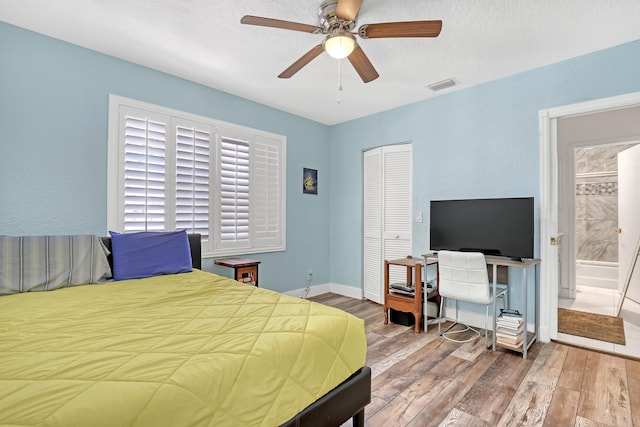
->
[382,144,413,290]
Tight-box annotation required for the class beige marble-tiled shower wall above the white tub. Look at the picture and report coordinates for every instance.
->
[575,144,632,262]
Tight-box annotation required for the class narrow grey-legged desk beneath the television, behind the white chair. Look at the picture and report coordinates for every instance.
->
[422,253,540,359]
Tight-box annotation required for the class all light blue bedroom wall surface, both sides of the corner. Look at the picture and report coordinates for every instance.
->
[0,23,640,300]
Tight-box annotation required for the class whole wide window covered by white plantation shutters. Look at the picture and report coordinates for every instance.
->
[107,95,286,256]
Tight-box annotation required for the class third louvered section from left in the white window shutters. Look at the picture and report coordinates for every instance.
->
[219,137,250,247]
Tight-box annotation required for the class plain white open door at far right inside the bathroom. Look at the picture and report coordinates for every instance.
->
[618,144,640,308]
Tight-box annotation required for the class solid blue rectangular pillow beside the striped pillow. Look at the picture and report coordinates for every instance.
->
[109,230,193,280]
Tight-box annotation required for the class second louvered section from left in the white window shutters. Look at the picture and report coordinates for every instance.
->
[175,121,213,242]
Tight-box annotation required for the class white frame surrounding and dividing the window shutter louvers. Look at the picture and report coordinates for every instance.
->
[107,94,287,257]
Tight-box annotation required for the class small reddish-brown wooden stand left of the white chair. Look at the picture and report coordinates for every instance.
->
[384,257,423,332]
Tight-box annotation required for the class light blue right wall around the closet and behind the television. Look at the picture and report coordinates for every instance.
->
[329,41,640,287]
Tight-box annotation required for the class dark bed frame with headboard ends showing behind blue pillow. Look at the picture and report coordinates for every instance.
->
[102,234,371,427]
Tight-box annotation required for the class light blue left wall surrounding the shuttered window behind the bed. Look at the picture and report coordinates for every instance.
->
[0,22,330,291]
